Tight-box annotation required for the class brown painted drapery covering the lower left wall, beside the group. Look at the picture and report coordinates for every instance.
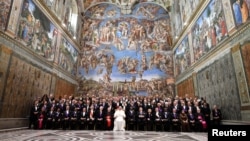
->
[0,45,76,118]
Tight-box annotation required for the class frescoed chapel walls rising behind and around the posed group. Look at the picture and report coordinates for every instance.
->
[0,0,250,138]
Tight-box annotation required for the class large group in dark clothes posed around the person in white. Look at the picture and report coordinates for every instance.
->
[29,94,222,132]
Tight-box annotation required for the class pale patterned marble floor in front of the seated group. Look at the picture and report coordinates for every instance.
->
[0,130,208,141]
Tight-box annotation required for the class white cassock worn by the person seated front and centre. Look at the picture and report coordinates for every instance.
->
[113,110,126,131]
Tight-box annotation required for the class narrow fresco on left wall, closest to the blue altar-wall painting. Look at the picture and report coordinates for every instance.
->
[58,38,78,75]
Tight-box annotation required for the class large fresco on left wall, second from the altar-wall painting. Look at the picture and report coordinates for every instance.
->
[16,0,58,61]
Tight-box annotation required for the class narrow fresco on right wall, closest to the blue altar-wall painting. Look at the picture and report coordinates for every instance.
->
[174,36,191,75]
